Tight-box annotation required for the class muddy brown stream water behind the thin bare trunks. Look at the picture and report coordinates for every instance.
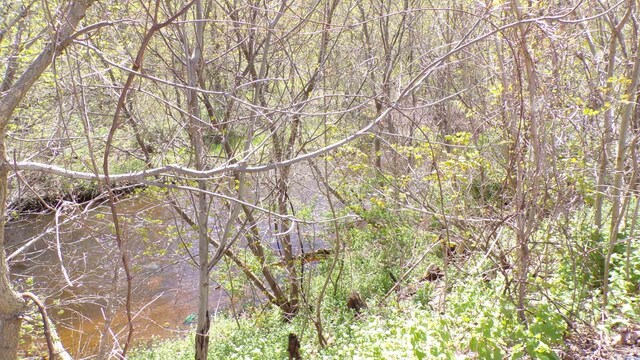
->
[5,196,228,358]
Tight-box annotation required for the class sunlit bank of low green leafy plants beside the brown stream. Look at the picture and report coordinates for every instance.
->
[131,205,640,360]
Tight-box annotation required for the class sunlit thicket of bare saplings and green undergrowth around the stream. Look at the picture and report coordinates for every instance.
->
[6,1,640,359]
